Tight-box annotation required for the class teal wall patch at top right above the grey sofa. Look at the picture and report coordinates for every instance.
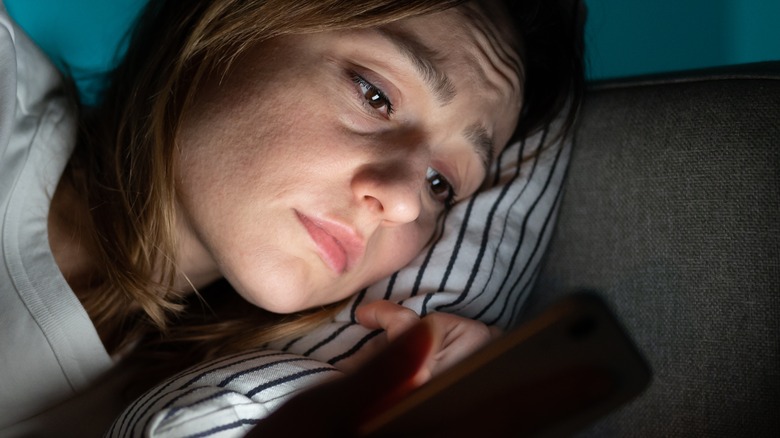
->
[585,0,780,79]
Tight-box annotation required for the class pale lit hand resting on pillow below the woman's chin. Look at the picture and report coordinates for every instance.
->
[356,300,500,384]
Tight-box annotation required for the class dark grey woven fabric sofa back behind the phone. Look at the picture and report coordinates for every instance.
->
[529,62,780,437]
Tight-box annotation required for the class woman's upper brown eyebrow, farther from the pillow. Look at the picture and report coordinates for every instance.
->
[377,26,457,106]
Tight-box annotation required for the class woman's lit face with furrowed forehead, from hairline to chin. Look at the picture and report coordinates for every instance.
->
[177,2,521,313]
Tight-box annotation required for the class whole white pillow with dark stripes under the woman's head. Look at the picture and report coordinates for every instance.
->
[107,121,571,437]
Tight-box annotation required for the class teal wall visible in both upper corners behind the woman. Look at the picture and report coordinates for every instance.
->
[6,0,780,96]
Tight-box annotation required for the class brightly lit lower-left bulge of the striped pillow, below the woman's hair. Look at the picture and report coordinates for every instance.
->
[105,350,341,437]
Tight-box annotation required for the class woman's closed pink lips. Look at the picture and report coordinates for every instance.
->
[296,211,365,274]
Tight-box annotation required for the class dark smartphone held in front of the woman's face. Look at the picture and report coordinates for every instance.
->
[361,292,651,437]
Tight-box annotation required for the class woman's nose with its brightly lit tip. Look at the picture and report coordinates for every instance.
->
[352,160,425,225]
